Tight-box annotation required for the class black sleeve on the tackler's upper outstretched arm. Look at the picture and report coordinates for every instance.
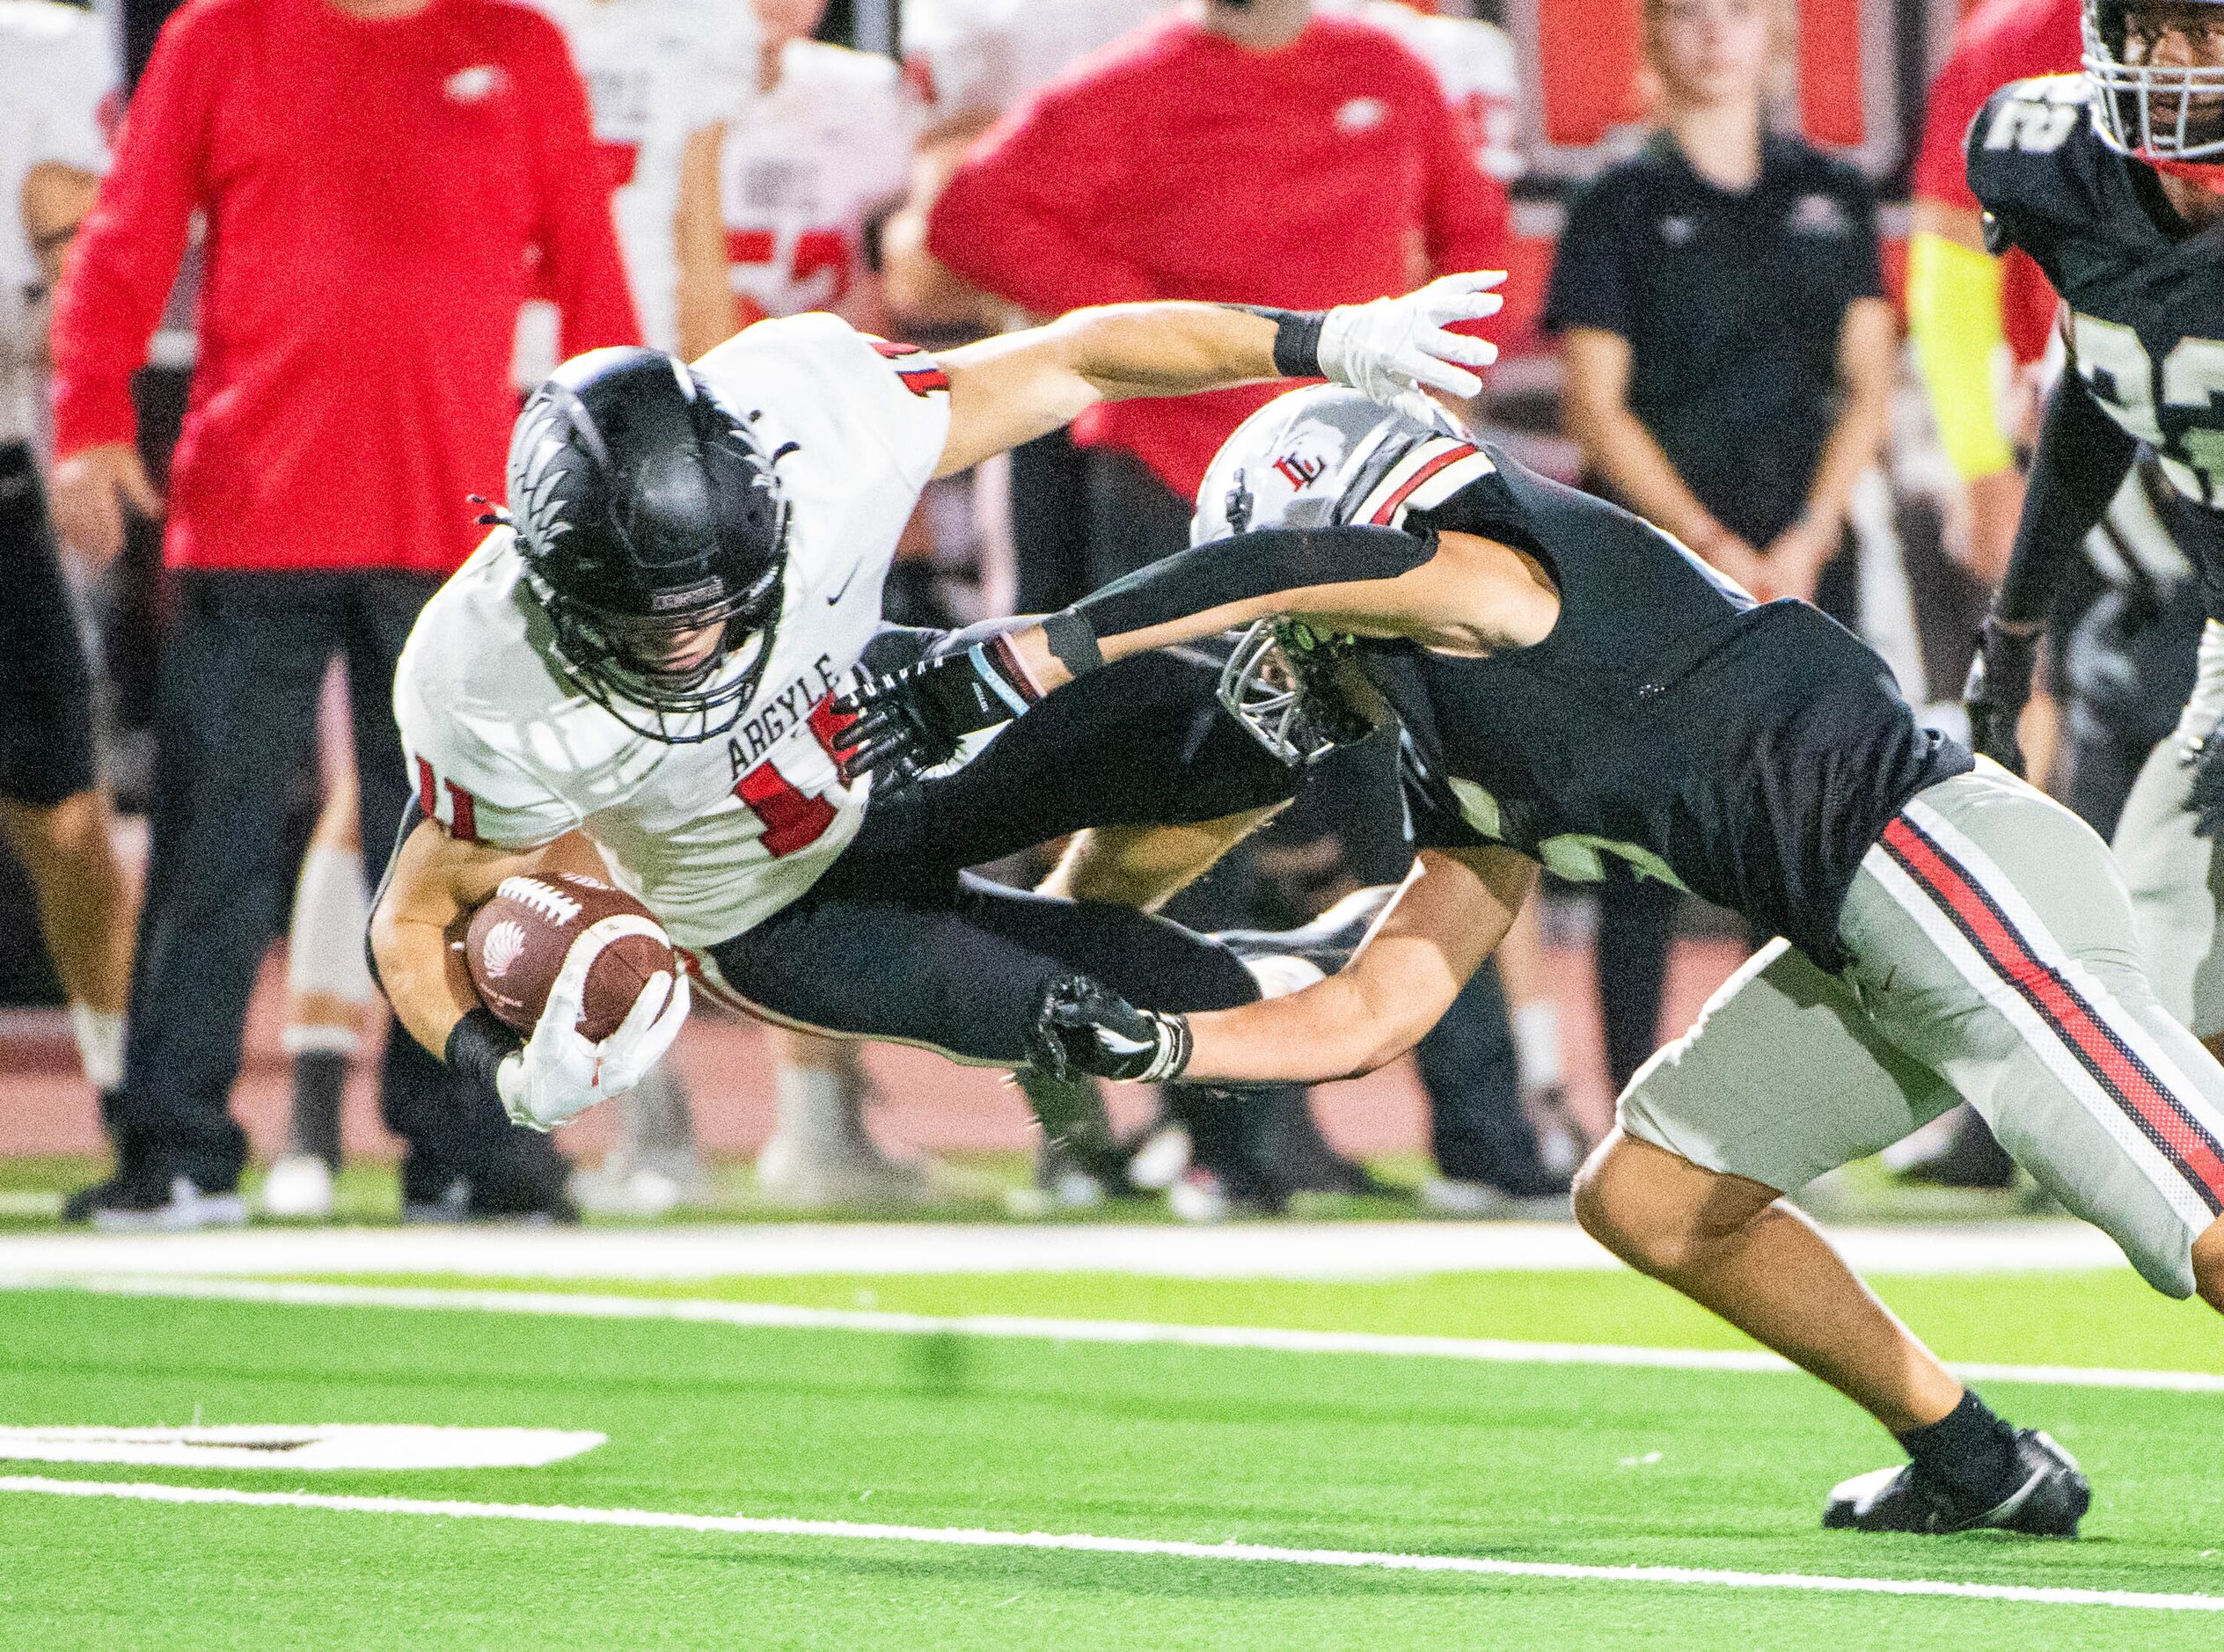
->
[1067,527,1437,638]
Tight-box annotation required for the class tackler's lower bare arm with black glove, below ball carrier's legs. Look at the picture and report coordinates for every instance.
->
[1029,844,1537,1083]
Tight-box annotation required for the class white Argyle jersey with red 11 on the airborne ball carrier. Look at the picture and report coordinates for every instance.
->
[393,316,949,947]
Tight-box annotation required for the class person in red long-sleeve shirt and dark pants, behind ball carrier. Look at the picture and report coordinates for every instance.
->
[54,0,639,1225]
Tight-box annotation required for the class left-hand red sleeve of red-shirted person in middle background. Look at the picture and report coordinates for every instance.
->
[927,84,1159,316]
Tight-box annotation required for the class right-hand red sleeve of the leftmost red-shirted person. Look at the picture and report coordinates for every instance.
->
[534,18,640,355]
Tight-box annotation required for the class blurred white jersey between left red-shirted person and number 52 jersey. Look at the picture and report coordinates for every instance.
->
[525,0,758,348]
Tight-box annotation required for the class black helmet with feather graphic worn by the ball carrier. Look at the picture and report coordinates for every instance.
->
[507,347,787,745]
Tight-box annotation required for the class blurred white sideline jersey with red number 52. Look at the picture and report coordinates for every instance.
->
[719,40,921,316]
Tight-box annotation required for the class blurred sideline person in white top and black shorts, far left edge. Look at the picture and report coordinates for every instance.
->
[0,0,135,1129]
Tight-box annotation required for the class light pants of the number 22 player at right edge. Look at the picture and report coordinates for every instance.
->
[2115,620,2224,1038]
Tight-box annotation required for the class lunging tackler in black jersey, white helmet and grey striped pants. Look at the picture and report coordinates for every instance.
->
[836,387,2224,1534]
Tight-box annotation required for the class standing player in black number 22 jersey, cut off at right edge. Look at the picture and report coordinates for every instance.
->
[1968,0,2224,1067]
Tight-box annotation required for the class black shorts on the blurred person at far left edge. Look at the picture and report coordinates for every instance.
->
[0,442,98,809]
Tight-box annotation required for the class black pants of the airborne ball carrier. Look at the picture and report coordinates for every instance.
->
[709,652,1297,1067]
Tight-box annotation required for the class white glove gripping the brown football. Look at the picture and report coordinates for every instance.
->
[494,914,687,1129]
